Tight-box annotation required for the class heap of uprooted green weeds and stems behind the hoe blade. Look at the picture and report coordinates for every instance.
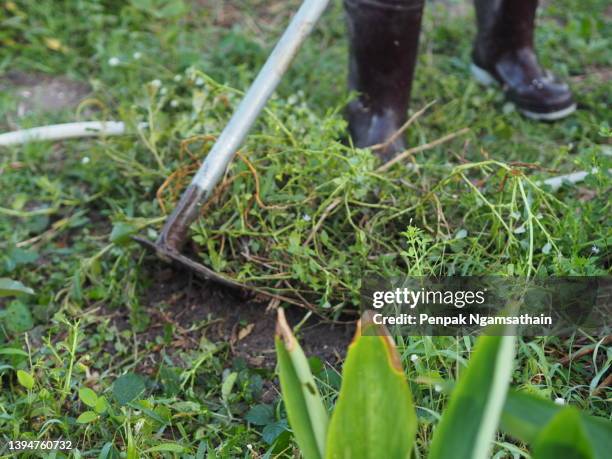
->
[124,72,611,313]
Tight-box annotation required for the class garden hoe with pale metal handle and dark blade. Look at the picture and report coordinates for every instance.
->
[134,0,329,288]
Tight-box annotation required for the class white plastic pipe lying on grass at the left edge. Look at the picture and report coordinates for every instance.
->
[0,121,125,147]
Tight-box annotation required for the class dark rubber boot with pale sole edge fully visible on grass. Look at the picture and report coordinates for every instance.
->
[472,0,576,121]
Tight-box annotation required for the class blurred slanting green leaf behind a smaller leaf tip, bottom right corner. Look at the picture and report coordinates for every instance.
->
[501,390,612,459]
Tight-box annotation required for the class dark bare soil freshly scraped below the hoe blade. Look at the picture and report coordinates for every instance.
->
[116,257,355,369]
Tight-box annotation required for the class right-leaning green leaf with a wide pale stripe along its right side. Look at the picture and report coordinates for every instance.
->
[429,336,515,459]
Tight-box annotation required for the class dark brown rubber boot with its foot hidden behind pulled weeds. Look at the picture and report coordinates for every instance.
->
[344,0,424,159]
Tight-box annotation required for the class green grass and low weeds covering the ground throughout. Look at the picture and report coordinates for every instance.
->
[0,0,612,457]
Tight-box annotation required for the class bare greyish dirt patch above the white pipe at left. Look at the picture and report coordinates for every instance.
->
[0,72,91,118]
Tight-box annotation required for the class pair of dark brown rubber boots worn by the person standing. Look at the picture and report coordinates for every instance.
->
[344,0,576,158]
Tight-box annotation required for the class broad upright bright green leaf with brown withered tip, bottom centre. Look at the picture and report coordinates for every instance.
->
[325,317,417,459]
